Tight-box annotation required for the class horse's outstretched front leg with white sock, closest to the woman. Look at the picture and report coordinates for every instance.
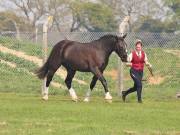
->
[92,67,112,100]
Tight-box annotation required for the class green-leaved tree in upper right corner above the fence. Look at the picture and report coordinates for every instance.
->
[135,0,180,32]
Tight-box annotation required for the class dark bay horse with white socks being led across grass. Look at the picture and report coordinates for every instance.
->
[36,35,127,101]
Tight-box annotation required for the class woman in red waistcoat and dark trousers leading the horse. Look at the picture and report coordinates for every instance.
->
[122,40,152,103]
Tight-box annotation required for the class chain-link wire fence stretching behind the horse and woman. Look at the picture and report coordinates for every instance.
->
[0,32,180,95]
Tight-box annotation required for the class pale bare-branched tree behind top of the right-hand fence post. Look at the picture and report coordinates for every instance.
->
[99,0,166,31]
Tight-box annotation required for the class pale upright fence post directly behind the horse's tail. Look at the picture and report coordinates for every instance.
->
[42,23,48,95]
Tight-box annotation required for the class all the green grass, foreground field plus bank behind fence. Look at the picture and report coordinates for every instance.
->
[0,38,180,135]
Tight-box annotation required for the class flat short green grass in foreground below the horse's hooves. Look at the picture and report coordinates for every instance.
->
[0,93,180,135]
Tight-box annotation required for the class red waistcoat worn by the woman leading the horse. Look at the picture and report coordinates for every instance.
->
[131,51,145,71]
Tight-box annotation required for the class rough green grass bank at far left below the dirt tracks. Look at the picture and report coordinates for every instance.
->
[0,64,41,93]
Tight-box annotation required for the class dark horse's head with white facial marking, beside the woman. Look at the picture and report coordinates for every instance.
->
[115,34,127,62]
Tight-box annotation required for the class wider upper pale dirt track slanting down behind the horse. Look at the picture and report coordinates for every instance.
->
[0,45,87,85]
